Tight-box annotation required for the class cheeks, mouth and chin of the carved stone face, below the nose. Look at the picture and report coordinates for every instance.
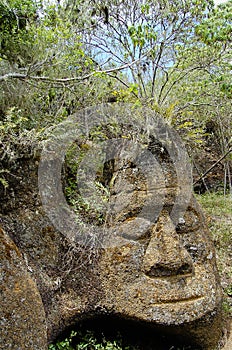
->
[99,241,221,325]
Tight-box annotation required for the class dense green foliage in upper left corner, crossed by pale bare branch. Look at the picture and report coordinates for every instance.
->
[0,0,113,129]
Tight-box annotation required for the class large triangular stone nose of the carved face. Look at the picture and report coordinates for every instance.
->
[142,216,193,277]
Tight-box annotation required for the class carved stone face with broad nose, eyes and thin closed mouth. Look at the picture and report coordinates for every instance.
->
[100,152,220,325]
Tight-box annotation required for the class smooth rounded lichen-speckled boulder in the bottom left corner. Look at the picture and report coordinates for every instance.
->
[0,228,47,350]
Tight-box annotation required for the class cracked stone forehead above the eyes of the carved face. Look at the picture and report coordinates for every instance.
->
[105,154,192,227]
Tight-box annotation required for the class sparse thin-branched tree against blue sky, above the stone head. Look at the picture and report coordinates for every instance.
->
[78,0,215,105]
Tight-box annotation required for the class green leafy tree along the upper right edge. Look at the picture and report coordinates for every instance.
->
[170,1,232,191]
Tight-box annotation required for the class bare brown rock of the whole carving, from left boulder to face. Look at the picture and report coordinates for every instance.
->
[0,133,225,350]
